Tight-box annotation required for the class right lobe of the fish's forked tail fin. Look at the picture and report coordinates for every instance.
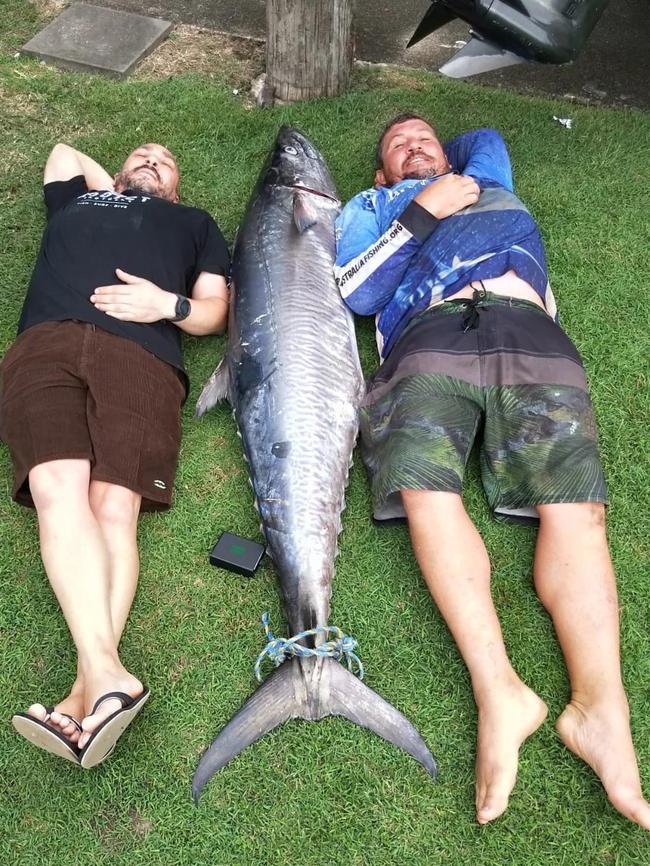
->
[328,661,437,779]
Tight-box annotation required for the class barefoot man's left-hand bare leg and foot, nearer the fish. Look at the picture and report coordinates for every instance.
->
[402,490,547,824]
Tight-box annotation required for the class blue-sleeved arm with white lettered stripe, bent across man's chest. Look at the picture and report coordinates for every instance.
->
[334,174,480,316]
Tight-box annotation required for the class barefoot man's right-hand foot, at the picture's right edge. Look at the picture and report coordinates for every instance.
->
[556,695,650,830]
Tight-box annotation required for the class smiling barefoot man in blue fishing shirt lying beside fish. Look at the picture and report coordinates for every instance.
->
[336,114,650,829]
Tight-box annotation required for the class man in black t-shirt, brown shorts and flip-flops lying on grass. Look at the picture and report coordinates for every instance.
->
[0,144,229,768]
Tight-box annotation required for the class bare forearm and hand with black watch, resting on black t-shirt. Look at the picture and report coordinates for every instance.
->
[90,268,228,337]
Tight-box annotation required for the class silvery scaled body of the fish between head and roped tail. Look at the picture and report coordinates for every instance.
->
[235,179,363,641]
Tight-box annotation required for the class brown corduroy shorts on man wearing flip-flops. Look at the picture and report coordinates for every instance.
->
[0,320,185,511]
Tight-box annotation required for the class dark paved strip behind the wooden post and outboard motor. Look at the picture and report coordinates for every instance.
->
[95,0,650,111]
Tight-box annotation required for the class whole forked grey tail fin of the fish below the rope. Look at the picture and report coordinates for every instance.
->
[192,657,437,802]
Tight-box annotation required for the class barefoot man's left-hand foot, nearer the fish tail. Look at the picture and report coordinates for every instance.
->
[476,680,548,824]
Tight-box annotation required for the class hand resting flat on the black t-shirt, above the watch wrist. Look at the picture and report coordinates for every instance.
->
[90,268,176,323]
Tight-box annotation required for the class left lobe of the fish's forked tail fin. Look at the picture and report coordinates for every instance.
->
[192,662,296,802]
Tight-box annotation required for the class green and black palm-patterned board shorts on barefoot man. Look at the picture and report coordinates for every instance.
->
[361,293,607,520]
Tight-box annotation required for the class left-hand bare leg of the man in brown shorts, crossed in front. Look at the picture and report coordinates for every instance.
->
[29,460,142,746]
